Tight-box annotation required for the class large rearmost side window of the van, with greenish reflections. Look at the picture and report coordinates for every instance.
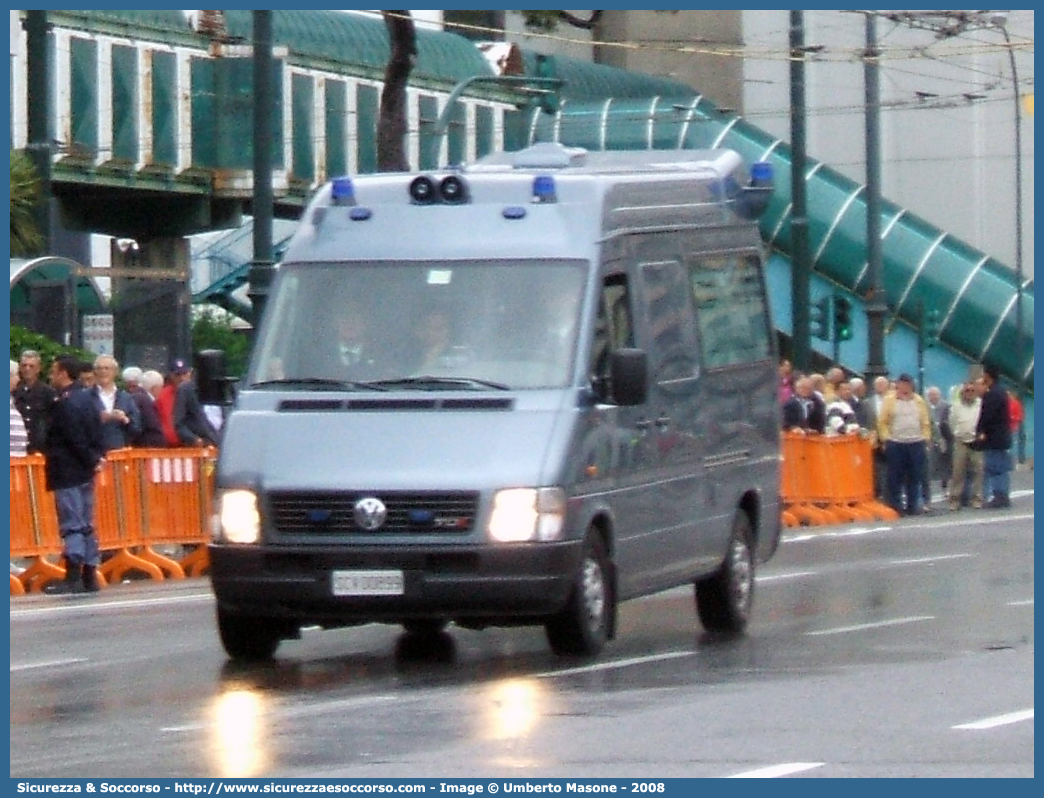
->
[686,253,770,369]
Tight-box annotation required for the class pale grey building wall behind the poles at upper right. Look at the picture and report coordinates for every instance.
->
[743,10,1034,276]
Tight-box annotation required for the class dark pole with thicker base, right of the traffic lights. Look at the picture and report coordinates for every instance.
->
[862,11,888,382]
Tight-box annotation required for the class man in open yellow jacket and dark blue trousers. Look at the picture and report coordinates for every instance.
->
[877,374,931,515]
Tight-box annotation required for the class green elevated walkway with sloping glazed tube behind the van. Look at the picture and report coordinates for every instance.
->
[15,10,1034,411]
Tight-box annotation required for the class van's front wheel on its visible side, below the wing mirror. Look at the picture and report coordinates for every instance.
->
[544,532,614,656]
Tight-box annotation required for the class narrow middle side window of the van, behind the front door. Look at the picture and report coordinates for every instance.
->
[641,260,699,382]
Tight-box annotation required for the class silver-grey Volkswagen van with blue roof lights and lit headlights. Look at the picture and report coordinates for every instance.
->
[210,144,780,659]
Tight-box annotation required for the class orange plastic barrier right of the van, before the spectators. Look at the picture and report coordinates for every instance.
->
[780,432,898,526]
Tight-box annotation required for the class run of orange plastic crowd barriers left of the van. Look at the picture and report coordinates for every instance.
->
[10,448,217,595]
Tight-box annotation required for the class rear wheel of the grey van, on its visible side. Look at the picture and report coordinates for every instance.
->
[695,511,754,632]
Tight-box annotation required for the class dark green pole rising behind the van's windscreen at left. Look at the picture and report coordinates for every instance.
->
[248,10,275,335]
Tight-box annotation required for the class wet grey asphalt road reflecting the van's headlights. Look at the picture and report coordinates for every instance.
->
[10,477,1034,778]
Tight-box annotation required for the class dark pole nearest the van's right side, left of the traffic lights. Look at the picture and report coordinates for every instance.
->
[790,10,812,372]
